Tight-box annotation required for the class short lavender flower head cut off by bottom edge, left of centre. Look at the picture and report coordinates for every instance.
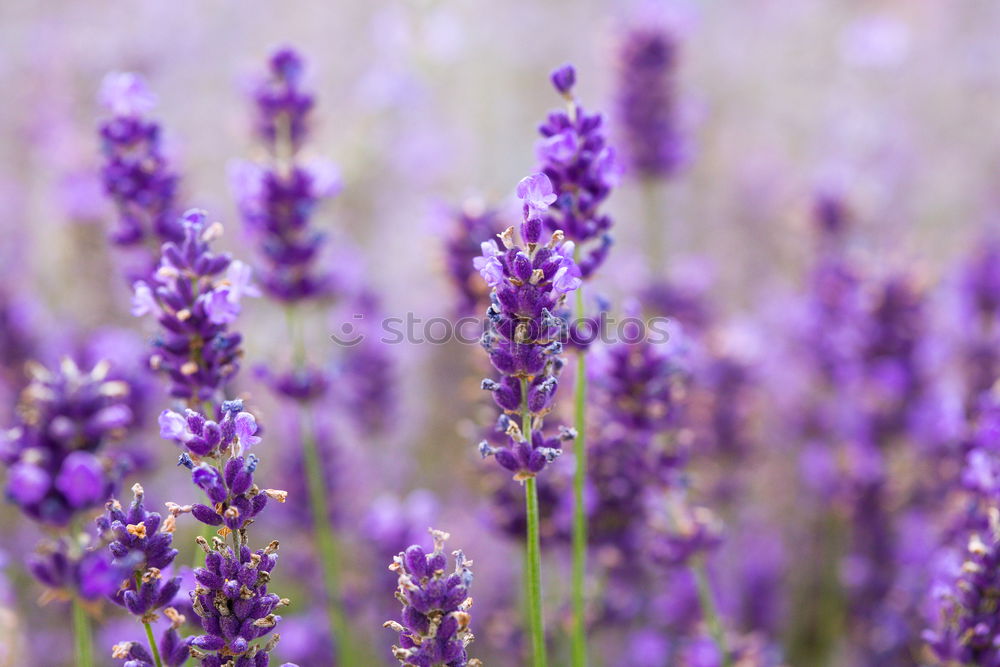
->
[384,530,482,667]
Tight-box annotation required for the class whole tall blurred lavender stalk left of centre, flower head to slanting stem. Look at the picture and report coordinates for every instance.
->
[232,48,357,665]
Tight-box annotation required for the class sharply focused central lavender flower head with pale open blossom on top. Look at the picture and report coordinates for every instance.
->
[475,174,581,480]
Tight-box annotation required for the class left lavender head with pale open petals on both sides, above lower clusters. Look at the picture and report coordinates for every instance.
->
[132,210,257,406]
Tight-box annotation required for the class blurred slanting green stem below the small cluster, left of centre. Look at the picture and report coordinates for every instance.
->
[300,410,357,665]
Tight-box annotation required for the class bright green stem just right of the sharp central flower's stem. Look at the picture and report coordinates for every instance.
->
[572,268,587,667]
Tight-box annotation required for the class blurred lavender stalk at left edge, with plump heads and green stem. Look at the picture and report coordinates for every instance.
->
[0,358,133,667]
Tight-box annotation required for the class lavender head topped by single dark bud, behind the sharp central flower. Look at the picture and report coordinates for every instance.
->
[540,65,621,278]
